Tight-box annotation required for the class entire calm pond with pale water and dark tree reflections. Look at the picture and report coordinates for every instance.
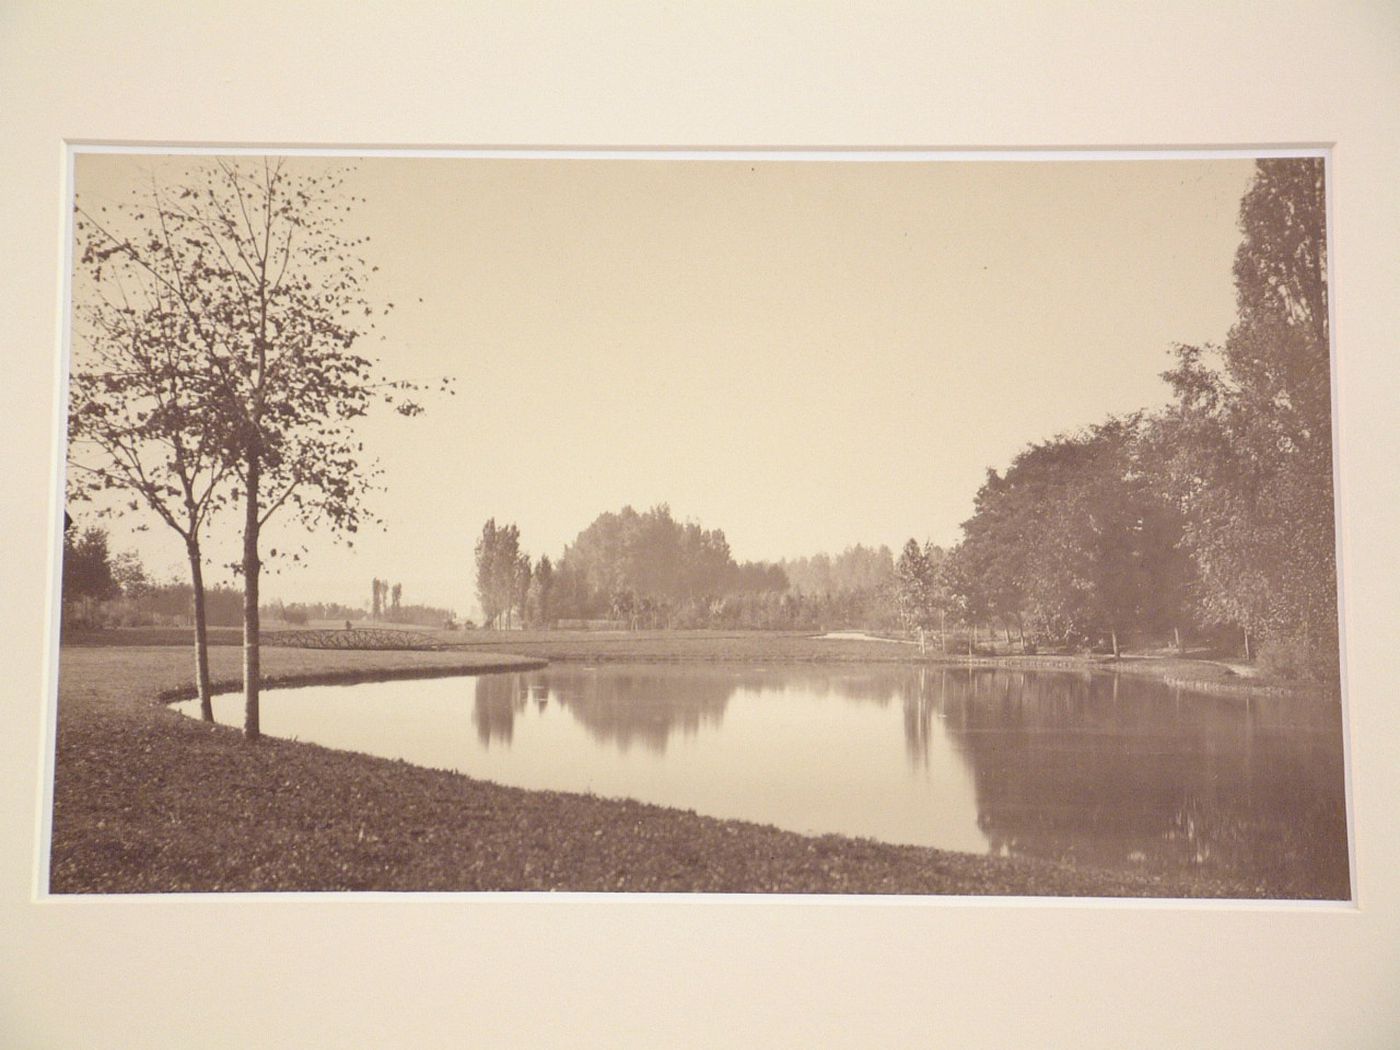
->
[172,664,1350,899]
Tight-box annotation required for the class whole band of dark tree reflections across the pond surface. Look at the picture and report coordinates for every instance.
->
[472,665,1350,899]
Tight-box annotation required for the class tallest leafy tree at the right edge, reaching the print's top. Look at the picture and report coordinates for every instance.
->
[1162,158,1337,673]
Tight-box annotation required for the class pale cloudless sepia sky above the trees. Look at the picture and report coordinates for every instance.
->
[74,154,1253,616]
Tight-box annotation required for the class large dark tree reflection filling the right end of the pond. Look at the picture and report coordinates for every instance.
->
[935,671,1348,896]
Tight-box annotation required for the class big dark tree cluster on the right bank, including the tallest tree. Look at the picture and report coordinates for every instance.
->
[945,160,1338,679]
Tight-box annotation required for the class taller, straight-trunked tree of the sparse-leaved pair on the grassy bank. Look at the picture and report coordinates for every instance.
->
[80,157,431,739]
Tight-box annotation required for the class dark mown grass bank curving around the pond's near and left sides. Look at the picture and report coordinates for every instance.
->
[50,643,1270,897]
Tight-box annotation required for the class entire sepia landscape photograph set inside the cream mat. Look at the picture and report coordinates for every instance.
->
[39,147,1355,902]
